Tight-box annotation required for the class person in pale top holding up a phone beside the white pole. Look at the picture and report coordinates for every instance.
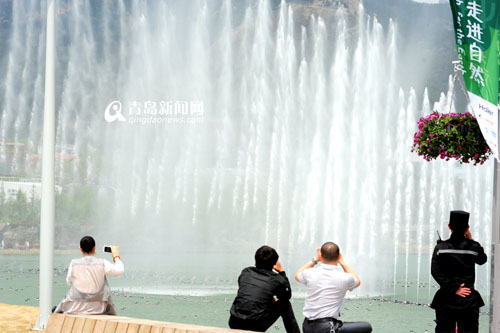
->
[54,236,124,315]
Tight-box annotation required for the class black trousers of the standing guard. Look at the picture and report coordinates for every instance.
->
[436,308,479,333]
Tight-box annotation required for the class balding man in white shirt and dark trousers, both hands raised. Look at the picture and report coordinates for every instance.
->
[295,242,372,333]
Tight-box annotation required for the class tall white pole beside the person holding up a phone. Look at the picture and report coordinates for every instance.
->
[35,0,56,330]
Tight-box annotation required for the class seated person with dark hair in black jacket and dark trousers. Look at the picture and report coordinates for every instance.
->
[229,245,300,333]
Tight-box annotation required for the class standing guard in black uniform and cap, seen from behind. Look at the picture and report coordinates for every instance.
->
[431,210,487,333]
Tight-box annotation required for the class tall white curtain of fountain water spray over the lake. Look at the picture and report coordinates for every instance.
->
[0,0,492,303]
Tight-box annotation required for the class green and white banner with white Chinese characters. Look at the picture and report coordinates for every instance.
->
[450,0,500,159]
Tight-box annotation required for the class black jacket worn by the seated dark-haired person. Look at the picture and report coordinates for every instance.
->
[230,267,292,320]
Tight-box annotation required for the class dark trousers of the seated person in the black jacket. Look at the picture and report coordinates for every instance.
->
[229,300,300,333]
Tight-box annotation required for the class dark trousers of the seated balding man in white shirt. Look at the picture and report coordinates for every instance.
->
[302,318,372,333]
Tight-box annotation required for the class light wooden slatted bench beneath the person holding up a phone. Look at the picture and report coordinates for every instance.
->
[45,314,256,333]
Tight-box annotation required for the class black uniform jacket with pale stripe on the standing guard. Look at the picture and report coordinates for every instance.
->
[431,234,487,310]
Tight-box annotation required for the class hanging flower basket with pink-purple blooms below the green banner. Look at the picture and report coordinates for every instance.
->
[411,111,491,165]
